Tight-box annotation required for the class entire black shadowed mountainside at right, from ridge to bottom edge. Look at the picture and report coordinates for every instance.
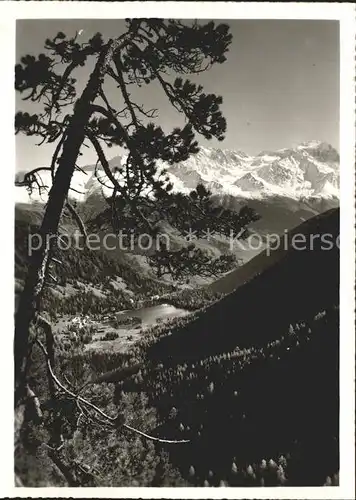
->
[131,210,339,486]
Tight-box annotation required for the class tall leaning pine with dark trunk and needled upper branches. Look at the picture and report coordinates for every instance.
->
[15,19,231,402]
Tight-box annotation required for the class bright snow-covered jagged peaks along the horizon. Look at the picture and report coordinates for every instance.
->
[16,141,339,202]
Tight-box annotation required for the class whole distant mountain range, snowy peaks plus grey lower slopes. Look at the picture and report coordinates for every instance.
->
[15,141,339,283]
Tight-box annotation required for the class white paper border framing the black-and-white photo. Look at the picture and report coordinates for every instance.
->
[0,1,355,499]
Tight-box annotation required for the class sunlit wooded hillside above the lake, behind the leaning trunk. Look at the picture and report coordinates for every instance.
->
[15,216,174,317]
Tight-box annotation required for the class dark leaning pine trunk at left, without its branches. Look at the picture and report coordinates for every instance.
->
[14,40,116,404]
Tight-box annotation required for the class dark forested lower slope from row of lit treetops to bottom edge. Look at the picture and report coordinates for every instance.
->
[133,307,339,486]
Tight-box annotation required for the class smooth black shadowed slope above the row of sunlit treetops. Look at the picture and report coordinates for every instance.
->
[150,205,339,363]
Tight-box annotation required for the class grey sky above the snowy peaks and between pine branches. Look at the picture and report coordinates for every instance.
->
[16,19,339,174]
